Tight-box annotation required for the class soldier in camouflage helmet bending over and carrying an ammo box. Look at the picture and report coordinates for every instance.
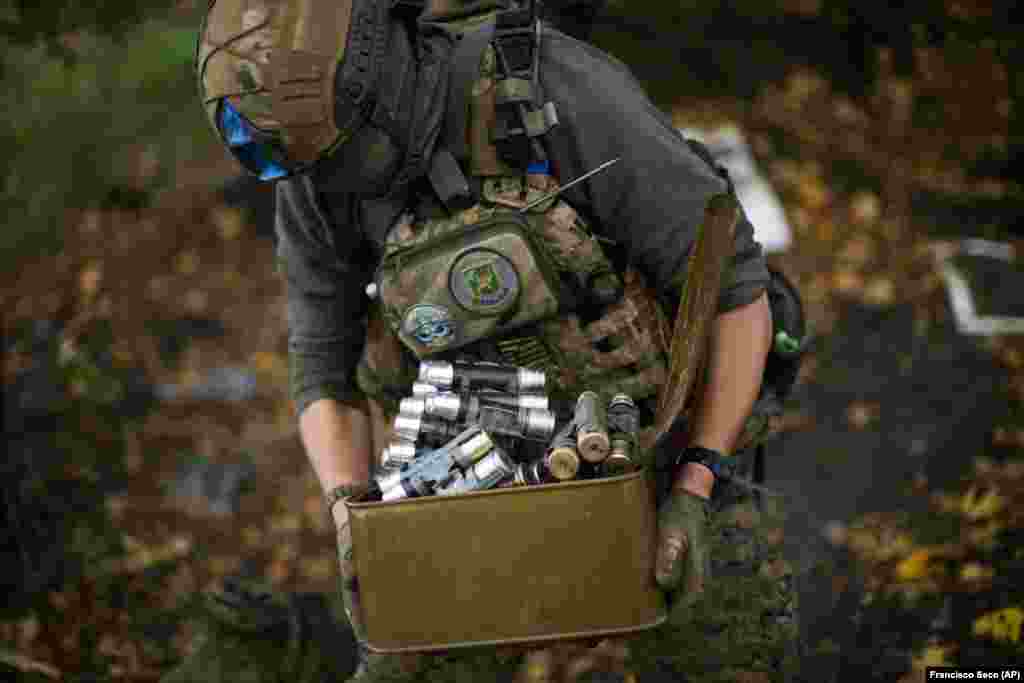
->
[182,0,806,680]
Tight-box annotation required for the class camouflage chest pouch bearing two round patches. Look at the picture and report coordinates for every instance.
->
[375,212,564,358]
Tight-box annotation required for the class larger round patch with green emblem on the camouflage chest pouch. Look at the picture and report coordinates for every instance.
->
[449,249,519,315]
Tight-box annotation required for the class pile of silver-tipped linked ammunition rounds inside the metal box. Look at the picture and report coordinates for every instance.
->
[370,360,639,501]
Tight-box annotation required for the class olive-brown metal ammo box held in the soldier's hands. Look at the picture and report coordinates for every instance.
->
[346,471,667,652]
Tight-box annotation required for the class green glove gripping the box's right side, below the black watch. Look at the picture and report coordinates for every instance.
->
[654,490,711,621]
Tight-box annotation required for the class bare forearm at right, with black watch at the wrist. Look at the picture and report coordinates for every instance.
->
[676,294,772,496]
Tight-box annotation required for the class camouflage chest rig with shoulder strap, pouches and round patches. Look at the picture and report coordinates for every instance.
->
[357,5,668,419]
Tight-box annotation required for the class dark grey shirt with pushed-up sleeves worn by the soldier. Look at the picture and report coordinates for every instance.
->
[276,30,768,412]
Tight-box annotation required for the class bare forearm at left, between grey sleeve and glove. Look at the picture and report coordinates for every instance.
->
[299,398,373,518]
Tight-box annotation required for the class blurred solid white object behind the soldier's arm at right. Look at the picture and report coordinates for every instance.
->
[679,125,793,253]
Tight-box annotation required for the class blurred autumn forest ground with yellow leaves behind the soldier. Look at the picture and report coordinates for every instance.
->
[0,0,1024,681]
